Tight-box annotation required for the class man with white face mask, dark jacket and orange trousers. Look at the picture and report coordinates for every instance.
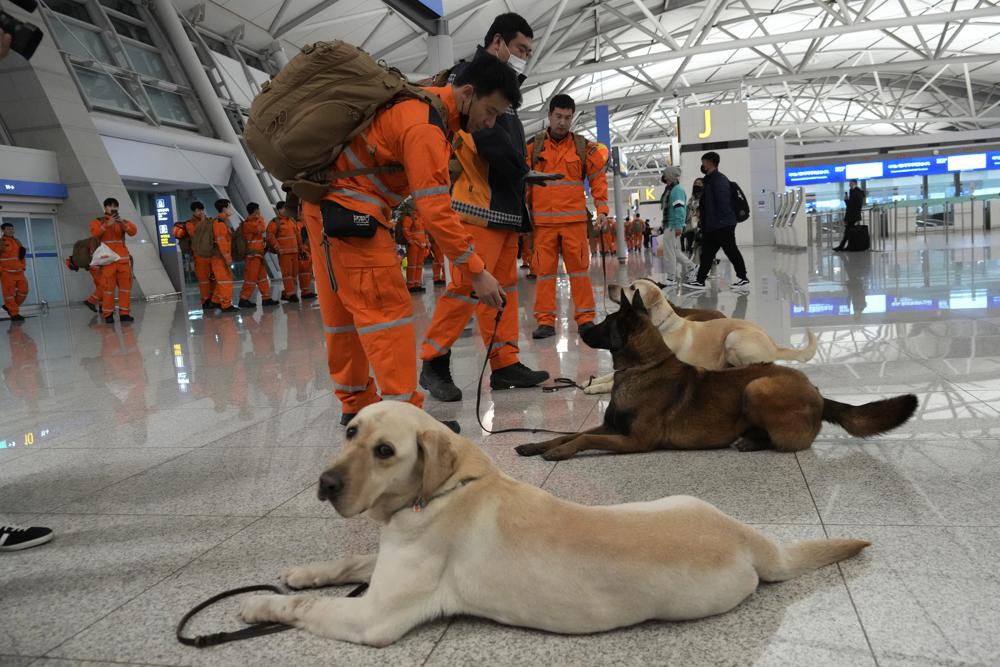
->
[420,14,549,402]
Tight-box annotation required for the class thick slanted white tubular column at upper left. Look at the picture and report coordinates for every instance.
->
[153,0,271,208]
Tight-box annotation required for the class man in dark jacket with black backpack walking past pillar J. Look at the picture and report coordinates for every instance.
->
[684,151,750,290]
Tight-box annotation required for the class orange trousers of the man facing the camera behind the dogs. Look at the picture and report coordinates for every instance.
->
[532,222,596,326]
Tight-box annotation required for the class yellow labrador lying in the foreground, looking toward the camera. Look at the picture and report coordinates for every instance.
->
[240,401,869,646]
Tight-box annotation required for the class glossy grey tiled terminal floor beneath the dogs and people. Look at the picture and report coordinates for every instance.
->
[0,235,1000,666]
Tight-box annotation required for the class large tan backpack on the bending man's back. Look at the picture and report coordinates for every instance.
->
[245,40,448,203]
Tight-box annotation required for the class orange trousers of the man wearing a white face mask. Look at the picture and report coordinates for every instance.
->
[420,225,519,370]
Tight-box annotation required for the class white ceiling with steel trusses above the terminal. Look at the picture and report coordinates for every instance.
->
[176,0,1000,173]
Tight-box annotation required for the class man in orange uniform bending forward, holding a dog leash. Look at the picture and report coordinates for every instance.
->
[303,60,521,428]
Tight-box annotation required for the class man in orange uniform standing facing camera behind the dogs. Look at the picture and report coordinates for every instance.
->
[528,95,608,338]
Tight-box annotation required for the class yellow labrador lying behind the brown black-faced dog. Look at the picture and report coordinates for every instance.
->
[583,278,816,394]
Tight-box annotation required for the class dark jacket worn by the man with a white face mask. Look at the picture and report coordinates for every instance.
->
[448,46,531,232]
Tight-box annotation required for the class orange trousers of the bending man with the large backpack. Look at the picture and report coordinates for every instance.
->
[302,202,424,413]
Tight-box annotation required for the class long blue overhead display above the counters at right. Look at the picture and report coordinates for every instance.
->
[785,151,1000,185]
